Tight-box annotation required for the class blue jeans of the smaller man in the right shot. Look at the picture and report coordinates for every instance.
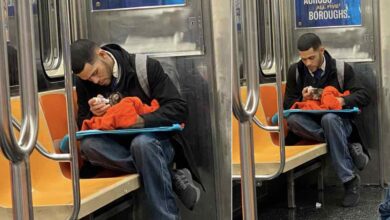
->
[287,113,355,183]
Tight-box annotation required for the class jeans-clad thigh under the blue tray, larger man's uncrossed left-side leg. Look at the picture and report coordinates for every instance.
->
[80,135,137,173]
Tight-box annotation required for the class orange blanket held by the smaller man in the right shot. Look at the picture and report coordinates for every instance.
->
[291,86,350,110]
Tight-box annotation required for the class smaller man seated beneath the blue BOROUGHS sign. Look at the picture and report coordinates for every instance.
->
[284,33,370,207]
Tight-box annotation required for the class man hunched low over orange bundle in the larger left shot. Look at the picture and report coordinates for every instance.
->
[71,39,200,219]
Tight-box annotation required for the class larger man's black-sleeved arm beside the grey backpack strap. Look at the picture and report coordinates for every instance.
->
[140,58,188,127]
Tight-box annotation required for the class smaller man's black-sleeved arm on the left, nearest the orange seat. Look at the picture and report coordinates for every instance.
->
[283,64,302,109]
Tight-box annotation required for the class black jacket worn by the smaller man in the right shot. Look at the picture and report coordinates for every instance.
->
[283,51,370,156]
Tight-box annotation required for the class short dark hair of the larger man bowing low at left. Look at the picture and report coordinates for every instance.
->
[70,39,99,74]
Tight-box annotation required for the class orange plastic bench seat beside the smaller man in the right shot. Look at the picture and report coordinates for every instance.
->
[232,86,327,176]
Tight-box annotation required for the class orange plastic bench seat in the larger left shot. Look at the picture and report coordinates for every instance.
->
[0,95,140,219]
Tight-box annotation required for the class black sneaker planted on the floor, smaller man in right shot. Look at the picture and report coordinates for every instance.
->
[342,174,360,207]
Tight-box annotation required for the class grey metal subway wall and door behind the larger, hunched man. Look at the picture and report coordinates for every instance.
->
[72,0,231,219]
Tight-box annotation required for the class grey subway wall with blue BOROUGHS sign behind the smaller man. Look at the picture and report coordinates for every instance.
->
[282,0,385,184]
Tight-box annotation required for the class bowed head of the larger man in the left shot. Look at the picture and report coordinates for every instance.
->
[70,39,114,86]
